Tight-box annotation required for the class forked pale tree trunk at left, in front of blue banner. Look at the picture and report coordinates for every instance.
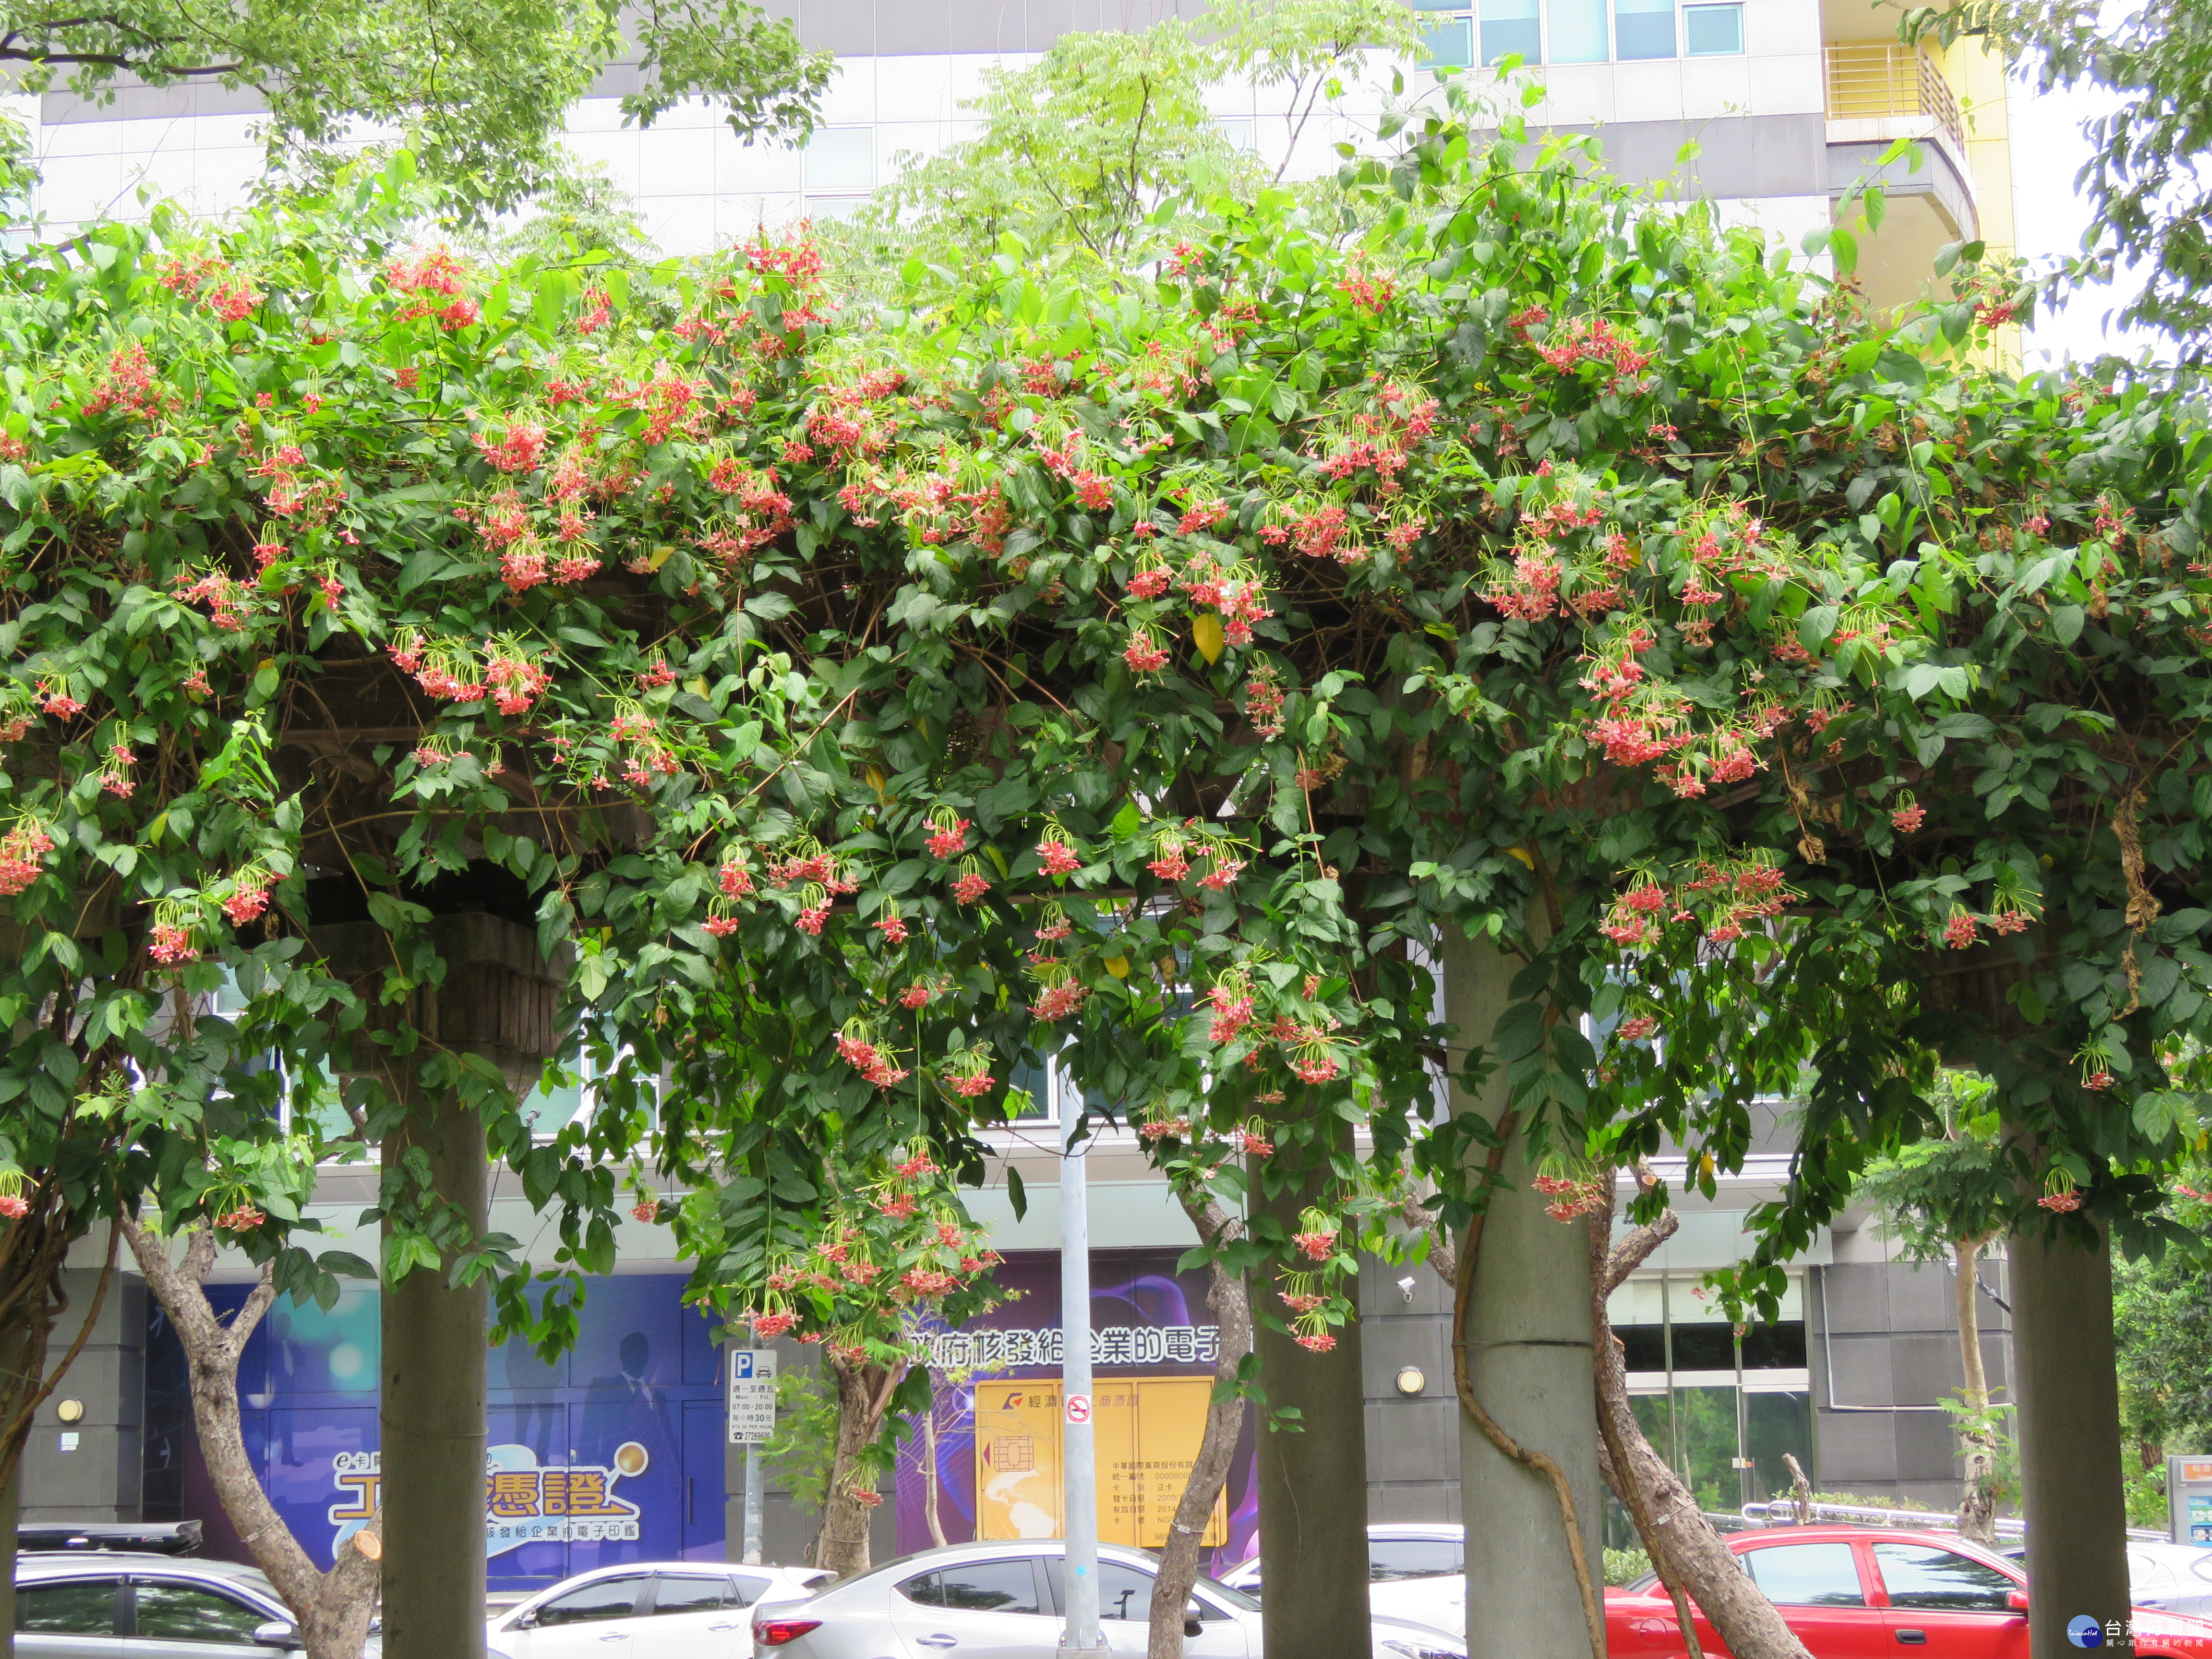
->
[124,1219,383,1659]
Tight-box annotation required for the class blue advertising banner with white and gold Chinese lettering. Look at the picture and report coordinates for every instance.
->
[148,1274,723,1590]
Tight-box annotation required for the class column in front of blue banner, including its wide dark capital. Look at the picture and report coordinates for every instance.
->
[314,914,562,1659]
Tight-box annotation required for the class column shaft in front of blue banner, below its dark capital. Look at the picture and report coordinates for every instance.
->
[378,1095,491,1659]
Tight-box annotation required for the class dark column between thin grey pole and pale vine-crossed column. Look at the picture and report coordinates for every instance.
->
[1252,1159,1374,1659]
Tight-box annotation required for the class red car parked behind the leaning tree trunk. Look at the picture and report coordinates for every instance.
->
[1606,1527,2212,1659]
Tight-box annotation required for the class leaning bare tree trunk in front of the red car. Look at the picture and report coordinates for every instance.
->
[1588,1201,1812,1659]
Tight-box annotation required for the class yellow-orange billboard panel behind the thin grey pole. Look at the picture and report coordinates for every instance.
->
[975,1376,1230,1551]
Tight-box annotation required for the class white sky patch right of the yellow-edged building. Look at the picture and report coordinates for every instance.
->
[2011,80,2159,370]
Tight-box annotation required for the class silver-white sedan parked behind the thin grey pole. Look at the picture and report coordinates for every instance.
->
[752,1538,1467,1659]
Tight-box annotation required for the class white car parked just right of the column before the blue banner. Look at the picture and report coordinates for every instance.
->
[484,1562,830,1659]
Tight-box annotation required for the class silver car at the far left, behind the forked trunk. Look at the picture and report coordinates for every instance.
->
[15,1551,383,1659]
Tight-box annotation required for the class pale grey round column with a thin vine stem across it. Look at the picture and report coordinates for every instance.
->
[1444,938,1604,1659]
